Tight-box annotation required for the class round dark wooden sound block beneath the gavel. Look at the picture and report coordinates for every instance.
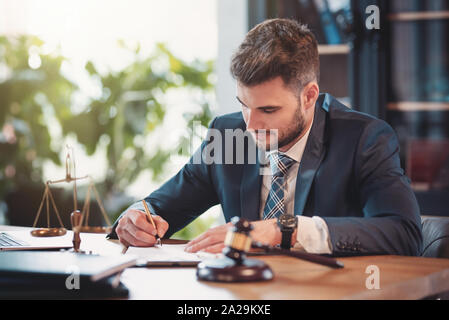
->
[196,257,273,282]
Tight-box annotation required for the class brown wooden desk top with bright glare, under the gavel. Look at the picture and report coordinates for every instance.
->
[0,226,449,300]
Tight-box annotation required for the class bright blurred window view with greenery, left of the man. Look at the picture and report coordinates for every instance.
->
[0,0,220,237]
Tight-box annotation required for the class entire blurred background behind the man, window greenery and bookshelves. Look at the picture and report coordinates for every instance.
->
[0,0,449,239]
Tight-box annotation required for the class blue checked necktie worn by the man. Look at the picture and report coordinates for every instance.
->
[263,152,296,220]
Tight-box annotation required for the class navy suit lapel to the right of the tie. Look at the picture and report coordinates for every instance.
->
[294,94,330,215]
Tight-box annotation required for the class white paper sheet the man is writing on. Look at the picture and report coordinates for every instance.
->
[126,244,221,265]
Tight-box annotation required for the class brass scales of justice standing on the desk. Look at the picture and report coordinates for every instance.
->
[31,147,112,252]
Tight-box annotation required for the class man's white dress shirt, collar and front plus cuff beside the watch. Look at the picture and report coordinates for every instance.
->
[260,119,332,254]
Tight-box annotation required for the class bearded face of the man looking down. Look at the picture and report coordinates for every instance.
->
[237,77,307,150]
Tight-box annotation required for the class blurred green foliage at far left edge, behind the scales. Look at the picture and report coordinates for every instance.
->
[0,36,76,200]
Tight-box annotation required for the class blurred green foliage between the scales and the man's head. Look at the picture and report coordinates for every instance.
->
[62,44,213,199]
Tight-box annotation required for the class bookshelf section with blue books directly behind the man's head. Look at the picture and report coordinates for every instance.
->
[248,0,351,106]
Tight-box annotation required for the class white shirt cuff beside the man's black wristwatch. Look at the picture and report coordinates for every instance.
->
[293,216,332,254]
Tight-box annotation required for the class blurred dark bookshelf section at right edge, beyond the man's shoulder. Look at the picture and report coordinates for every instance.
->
[386,1,449,215]
